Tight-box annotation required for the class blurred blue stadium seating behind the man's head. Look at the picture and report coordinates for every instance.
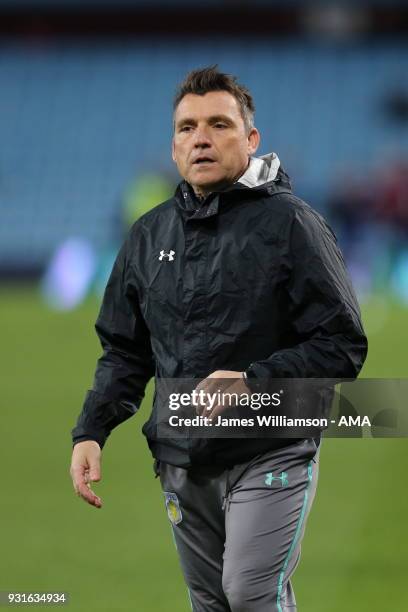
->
[0,39,408,265]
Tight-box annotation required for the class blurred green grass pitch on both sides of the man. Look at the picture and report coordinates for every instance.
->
[0,289,408,612]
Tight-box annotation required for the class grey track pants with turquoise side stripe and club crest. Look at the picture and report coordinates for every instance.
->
[160,439,319,612]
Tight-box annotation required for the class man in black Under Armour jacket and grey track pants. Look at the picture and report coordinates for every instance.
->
[71,67,367,612]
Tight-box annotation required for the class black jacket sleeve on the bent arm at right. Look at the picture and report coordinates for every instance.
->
[251,204,367,379]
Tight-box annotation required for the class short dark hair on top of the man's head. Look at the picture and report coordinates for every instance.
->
[173,64,255,132]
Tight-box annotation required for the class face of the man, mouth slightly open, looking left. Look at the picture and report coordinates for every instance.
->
[172,91,259,196]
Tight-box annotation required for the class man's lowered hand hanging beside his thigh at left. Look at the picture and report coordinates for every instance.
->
[70,440,102,508]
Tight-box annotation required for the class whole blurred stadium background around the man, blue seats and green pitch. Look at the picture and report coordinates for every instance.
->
[0,0,408,612]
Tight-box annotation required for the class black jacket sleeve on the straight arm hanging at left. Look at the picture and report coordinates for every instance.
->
[72,234,155,448]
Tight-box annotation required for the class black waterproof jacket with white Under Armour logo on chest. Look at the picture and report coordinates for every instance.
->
[72,155,367,466]
